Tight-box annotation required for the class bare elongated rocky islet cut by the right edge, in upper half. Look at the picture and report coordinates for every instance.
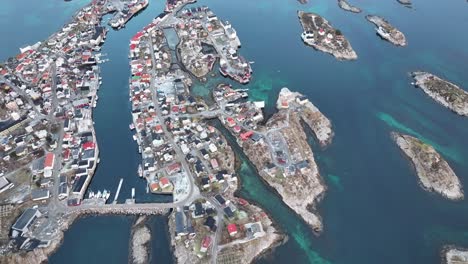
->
[411,71,468,116]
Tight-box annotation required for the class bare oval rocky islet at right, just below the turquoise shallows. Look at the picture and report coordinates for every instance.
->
[391,132,464,200]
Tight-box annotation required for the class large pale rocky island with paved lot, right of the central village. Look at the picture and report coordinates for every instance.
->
[222,88,333,233]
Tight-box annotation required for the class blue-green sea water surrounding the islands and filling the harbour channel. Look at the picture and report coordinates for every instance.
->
[0,0,468,263]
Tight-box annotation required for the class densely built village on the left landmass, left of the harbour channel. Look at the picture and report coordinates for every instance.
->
[0,0,147,258]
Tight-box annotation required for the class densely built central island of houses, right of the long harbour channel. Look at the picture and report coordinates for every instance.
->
[130,5,279,263]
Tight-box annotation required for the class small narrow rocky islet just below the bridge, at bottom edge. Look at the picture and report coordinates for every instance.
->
[129,216,151,264]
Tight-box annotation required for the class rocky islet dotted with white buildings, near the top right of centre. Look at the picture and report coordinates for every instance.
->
[298,11,357,60]
